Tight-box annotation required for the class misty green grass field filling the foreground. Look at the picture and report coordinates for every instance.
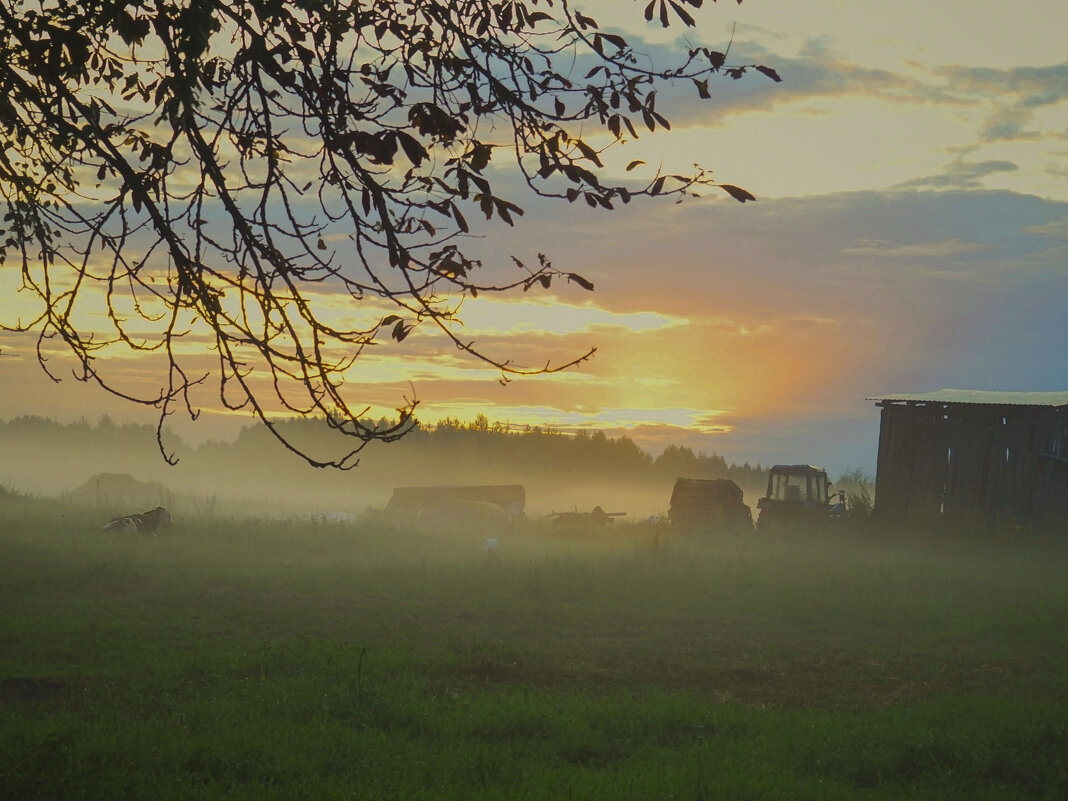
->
[0,493,1068,801]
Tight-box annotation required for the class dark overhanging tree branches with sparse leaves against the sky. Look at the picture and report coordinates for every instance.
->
[0,0,779,468]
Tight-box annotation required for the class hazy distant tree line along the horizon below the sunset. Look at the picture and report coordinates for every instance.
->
[0,414,766,486]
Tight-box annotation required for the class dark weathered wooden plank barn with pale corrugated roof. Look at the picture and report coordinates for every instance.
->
[868,390,1068,525]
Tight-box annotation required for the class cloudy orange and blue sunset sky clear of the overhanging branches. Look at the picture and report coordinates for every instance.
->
[0,0,1068,473]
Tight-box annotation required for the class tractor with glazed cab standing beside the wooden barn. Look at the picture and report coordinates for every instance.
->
[756,465,845,531]
